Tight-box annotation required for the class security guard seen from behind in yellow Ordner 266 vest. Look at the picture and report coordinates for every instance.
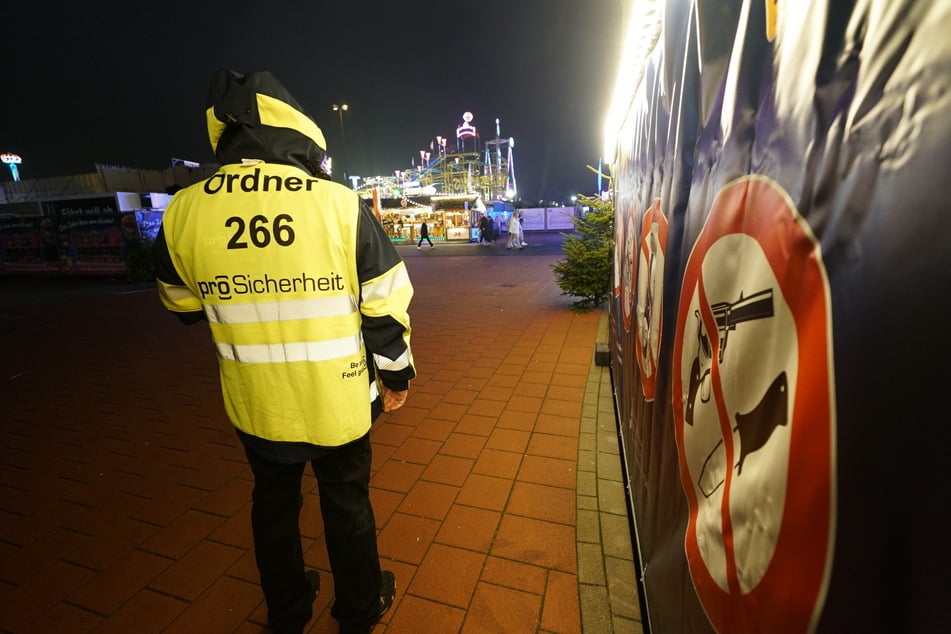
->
[155,70,416,633]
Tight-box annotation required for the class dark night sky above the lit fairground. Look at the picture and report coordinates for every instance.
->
[0,0,622,201]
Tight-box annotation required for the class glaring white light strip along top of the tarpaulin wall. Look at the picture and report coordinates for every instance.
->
[604,0,663,164]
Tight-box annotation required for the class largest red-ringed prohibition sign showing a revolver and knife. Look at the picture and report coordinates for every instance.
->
[672,176,836,633]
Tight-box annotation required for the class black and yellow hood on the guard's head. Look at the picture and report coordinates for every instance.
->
[205,69,327,176]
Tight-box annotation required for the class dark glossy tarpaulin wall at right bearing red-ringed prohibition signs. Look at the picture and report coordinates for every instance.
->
[609,0,951,634]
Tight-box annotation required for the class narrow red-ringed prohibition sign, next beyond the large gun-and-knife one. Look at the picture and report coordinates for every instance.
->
[634,198,667,401]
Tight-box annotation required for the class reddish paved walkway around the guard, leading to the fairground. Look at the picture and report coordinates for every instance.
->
[0,235,642,634]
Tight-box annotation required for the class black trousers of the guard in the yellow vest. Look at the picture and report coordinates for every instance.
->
[245,434,381,631]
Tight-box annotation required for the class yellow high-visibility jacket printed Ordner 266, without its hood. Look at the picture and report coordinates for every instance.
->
[155,69,415,446]
